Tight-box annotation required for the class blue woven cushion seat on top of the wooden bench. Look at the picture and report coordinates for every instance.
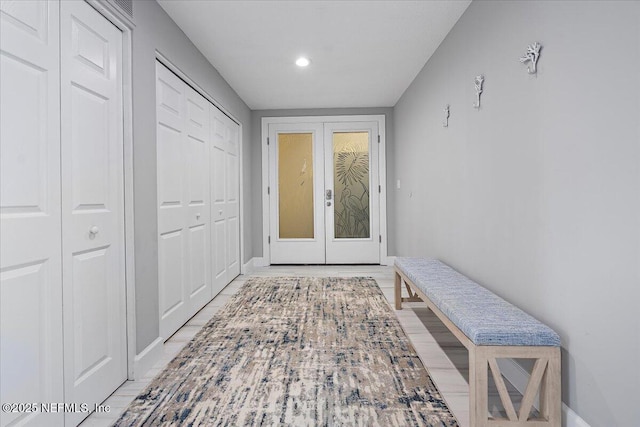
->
[395,258,560,347]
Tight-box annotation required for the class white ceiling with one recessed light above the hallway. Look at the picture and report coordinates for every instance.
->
[158,0,471,110]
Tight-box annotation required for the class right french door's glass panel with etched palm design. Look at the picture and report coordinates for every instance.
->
[333,132,371,239]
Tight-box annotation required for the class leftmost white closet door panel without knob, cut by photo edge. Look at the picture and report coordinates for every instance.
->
[0,1,63,426]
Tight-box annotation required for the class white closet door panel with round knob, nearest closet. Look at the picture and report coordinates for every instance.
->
[60,1,127,425]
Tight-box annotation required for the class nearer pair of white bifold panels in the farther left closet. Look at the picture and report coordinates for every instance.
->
[156,62,212,339]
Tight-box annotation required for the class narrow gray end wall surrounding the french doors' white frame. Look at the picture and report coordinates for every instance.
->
[251,107,395,257]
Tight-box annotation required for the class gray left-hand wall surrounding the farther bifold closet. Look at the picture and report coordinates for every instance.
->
[133,1,251,353]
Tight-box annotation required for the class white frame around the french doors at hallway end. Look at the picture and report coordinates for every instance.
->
[259,114,387,265]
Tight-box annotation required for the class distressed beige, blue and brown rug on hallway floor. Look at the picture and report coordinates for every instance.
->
[116,277,458,427]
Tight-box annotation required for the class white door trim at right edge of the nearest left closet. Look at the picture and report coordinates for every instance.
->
[86,0,136,380]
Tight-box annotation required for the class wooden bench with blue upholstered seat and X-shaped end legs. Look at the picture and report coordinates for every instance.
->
[395,258,561,427]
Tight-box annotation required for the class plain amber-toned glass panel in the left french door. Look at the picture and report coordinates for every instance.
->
[278,133,314,239]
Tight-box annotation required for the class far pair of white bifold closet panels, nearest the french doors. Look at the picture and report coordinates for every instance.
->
[210,105,240,295]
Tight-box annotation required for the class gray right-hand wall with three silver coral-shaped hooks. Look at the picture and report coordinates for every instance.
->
[394,1,640,426]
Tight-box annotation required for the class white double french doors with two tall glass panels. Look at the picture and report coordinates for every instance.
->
[268,121,381,264]
